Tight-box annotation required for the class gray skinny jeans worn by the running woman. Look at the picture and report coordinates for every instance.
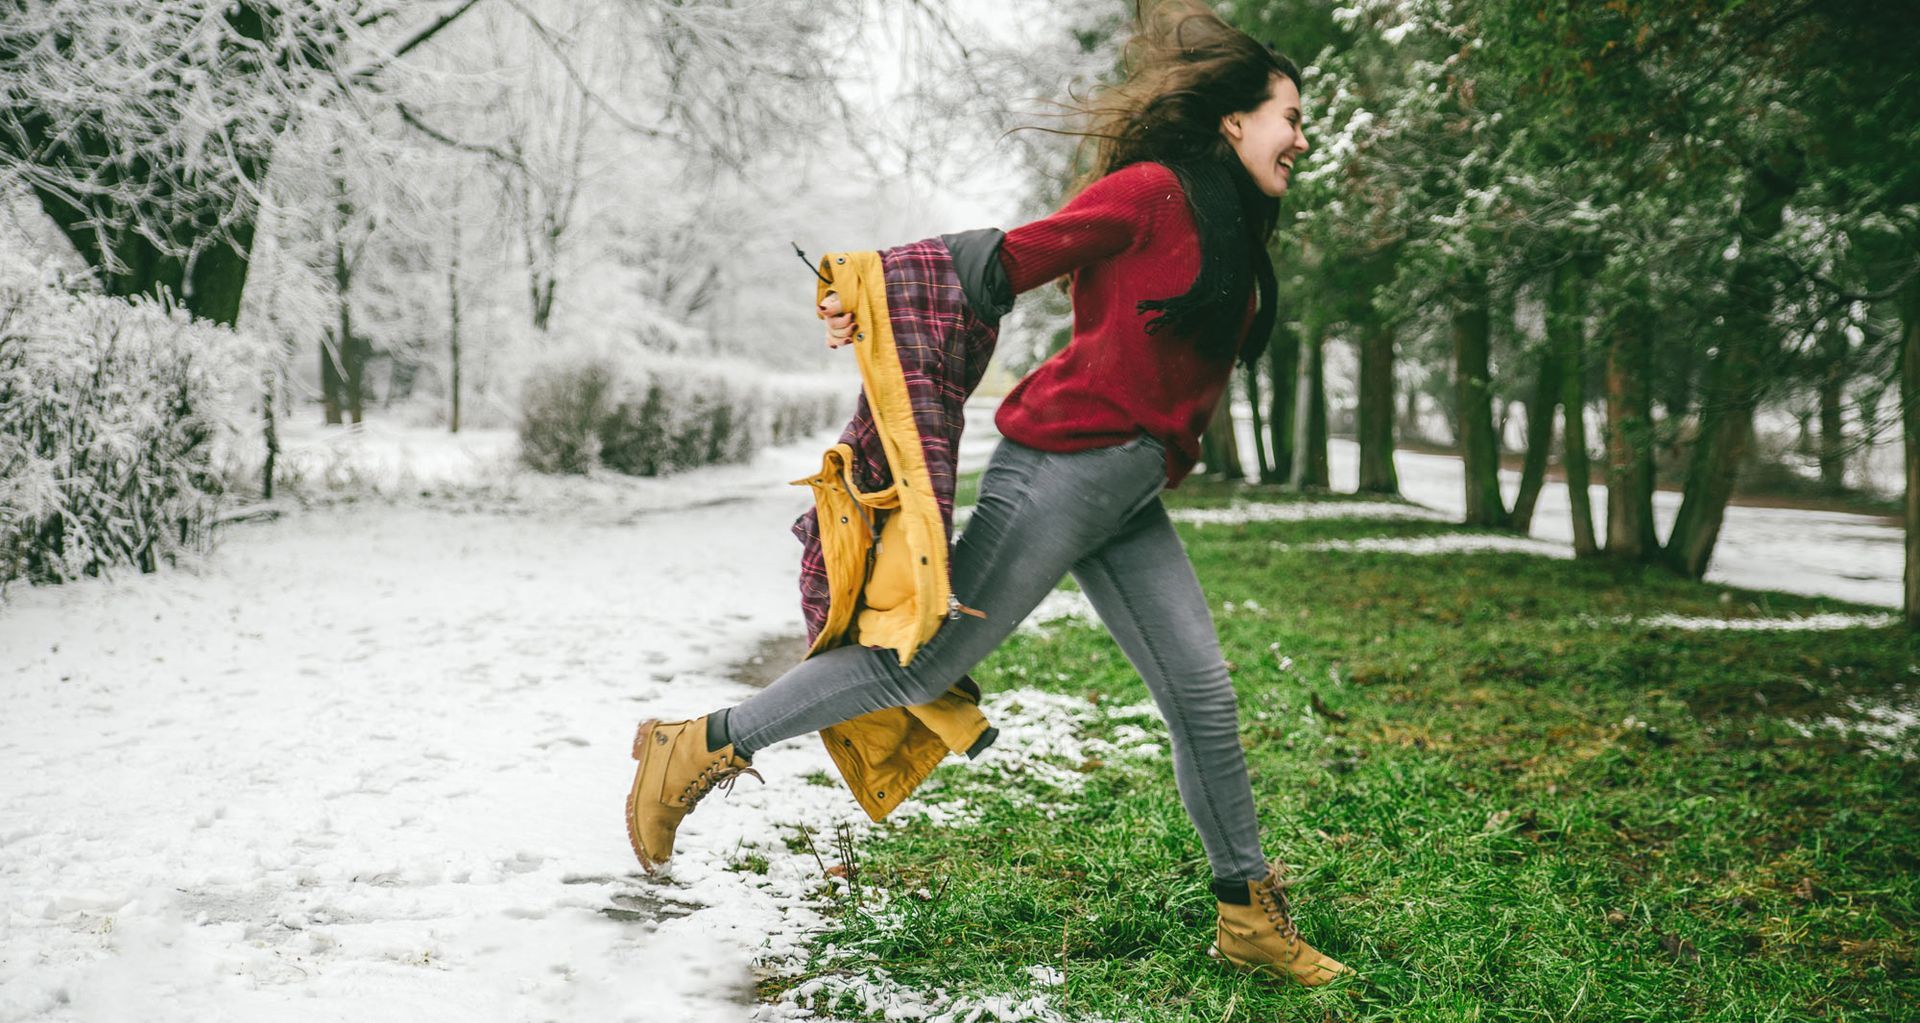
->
[726,434,1267,881]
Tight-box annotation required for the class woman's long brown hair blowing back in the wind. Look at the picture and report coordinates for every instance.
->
[1062,0,1300,244]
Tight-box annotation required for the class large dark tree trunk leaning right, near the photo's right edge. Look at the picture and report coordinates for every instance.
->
[1667,150,1801,580]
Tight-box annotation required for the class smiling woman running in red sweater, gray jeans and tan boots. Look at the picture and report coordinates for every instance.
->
[628,0,1350,985]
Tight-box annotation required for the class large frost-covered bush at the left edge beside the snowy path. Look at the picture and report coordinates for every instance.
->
[0,255,257,583]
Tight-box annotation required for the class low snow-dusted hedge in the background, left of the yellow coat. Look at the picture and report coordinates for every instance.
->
[520,339,858,476]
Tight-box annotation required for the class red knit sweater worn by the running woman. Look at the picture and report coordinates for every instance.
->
[993,163,1256,489]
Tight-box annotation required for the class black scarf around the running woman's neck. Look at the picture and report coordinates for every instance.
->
[1135,159,1279,367]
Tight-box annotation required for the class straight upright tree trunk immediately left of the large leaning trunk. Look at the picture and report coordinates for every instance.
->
[1607,301,1661,562]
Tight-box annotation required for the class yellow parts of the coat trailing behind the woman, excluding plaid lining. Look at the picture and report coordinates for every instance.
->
[791,250,996,821]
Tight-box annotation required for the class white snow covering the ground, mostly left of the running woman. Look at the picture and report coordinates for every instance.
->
[0,395,1897,1021]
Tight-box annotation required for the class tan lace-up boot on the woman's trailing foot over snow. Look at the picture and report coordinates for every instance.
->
[626,714,766,873]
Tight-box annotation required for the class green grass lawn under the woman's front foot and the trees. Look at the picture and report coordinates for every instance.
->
[766,470,1920,1023]
